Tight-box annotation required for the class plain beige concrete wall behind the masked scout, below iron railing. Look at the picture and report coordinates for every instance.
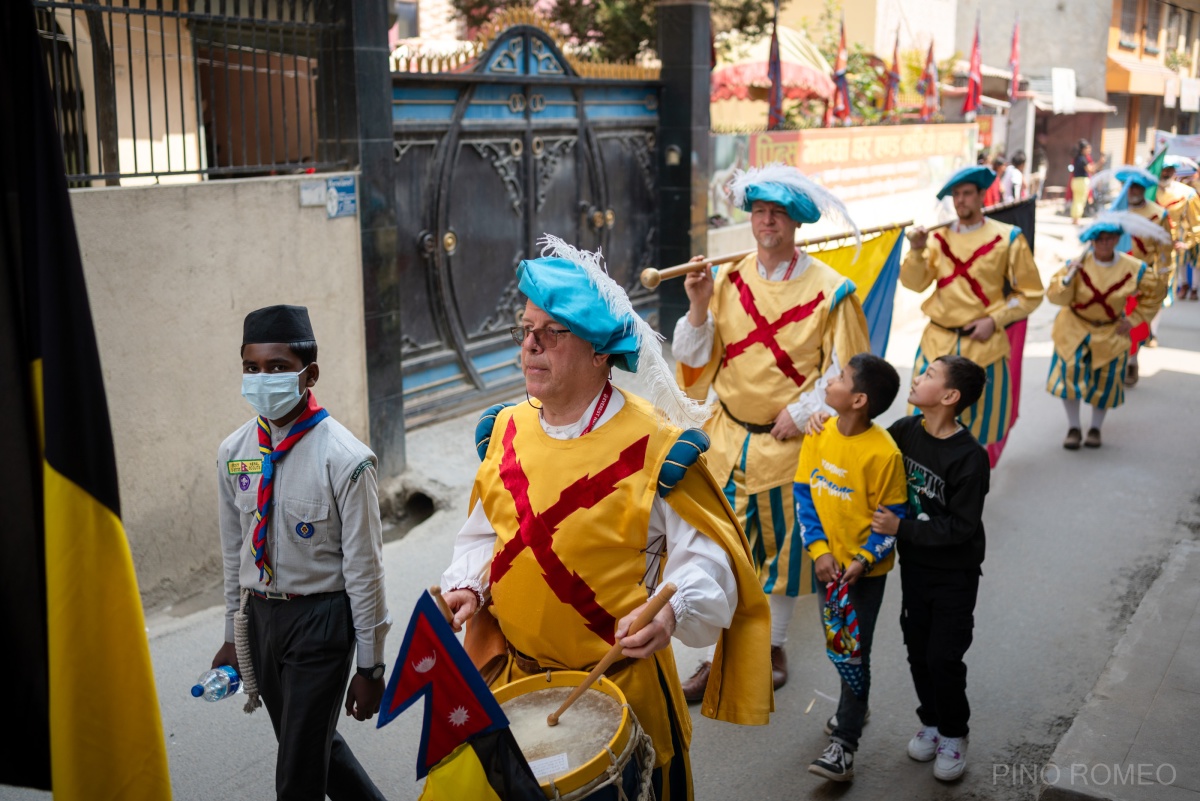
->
[71,176,367,604]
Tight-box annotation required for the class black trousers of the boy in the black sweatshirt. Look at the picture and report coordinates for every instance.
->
[900,565,979,737]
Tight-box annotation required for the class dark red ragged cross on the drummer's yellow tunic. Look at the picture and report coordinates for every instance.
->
[491,417,650,645]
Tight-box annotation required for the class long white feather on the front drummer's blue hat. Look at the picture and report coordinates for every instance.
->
[538,234,713,428]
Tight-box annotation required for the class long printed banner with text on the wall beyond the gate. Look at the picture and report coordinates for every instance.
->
[708,124,979,222]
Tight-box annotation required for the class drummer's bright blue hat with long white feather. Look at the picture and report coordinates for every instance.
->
[517,234,712,428]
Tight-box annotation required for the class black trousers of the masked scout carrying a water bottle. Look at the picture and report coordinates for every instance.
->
[248,592,384,801]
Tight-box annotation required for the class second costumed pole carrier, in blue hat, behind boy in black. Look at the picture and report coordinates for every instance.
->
[900,167,1043,446]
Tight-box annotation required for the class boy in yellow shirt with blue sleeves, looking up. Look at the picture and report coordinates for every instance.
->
[793,354,908,782]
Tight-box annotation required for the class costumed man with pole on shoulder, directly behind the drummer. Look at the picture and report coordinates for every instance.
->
[672,164,871,700]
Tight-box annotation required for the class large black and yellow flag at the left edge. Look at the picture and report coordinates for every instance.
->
[0,0,170,801]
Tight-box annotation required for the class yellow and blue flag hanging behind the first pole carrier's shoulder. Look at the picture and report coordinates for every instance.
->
[809,228,904,356]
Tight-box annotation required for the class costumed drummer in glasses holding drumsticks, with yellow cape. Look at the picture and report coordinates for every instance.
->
[442,236,774,801]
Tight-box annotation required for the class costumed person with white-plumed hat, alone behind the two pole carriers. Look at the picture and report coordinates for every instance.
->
[1046,211,1170,451]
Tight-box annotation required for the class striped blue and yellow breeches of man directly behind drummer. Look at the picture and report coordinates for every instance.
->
[725,434,815,597]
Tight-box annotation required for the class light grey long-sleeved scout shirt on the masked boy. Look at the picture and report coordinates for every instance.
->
[217,417,391,667]
